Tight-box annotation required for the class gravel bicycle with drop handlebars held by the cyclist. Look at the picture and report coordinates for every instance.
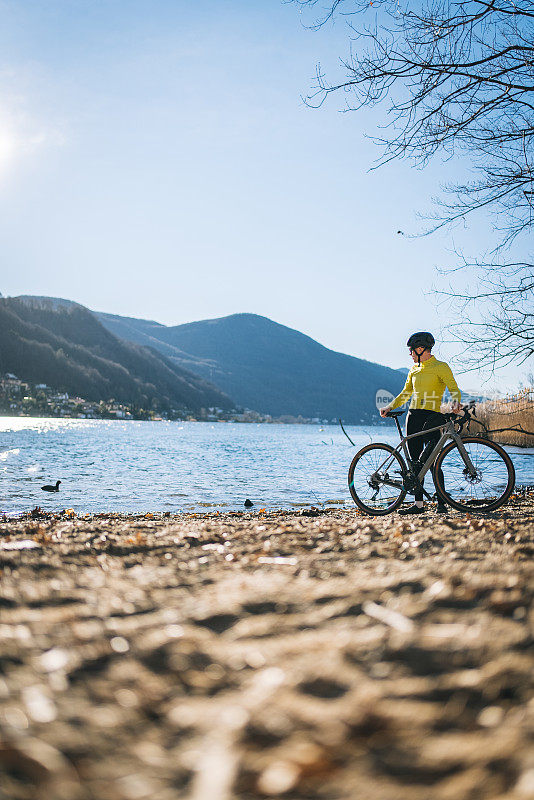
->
[349,403,515,516]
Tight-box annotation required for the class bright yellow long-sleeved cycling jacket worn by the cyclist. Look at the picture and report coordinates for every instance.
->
[390,356,462,411]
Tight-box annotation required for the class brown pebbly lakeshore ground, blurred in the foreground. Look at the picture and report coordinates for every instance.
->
[0,495,534,800]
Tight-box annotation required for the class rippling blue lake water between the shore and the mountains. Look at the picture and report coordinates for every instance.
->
[0,417,534,514]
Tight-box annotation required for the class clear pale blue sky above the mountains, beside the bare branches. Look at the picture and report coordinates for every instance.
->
[0,0,527,388]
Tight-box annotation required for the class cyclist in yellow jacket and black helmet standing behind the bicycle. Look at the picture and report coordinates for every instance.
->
[380,331,462,514]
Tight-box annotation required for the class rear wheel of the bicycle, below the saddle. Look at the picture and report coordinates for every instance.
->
[349,444,406,516]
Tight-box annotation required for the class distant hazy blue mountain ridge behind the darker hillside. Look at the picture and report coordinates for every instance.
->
[95,312,404,422]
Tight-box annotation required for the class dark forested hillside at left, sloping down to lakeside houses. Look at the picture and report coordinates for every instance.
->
[0,298,234,411]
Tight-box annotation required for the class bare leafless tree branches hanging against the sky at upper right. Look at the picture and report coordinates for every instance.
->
[291,0,534,367]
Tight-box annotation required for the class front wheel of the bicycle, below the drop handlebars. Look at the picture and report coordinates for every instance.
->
[434,436,515,511]
